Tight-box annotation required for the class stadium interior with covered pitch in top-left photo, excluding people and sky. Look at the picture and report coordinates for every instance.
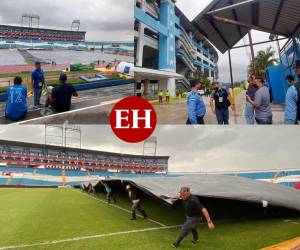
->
[0,14,134,124]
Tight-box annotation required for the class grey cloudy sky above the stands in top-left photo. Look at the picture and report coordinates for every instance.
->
[0,0,134,41]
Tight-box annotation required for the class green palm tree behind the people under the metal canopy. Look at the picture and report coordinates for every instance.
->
[248,47,278,78]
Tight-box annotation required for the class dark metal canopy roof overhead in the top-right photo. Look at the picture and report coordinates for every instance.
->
[193,0,300,53]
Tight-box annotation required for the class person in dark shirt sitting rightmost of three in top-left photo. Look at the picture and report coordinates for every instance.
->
[45,73,78,113]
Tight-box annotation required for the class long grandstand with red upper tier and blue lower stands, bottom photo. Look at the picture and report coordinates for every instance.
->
[0,140,169,185]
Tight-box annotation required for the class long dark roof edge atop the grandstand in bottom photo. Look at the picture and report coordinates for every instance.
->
[0,140,170,159]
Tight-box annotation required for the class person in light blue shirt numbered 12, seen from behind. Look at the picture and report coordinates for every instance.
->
[5,76,27,120]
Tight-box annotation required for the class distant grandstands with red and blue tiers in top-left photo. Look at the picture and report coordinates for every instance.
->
[0,23,133,54]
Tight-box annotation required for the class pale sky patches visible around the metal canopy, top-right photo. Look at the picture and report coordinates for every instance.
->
[177,0,284,82]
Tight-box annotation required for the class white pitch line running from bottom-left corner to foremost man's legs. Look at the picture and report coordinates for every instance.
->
[0,225,181,250]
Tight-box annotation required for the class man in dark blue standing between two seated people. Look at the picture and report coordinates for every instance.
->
[31,62,45,108]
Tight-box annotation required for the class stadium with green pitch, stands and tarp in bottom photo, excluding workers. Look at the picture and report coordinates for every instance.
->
[0,140,300,250]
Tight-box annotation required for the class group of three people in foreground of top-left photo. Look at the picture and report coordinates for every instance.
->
[5,62,78,120]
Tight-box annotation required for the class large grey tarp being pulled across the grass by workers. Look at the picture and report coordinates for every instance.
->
[105,175,300,211]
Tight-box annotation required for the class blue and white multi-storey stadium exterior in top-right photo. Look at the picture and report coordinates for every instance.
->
[134,0,218,95]
